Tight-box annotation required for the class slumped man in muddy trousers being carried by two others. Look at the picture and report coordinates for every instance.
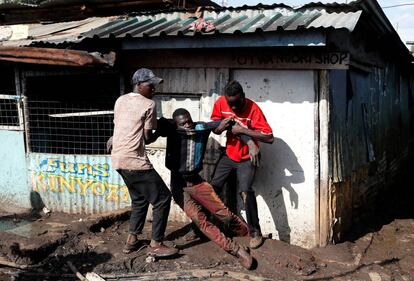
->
[158,108,258,269]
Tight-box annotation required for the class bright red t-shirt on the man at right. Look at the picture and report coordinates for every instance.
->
[210,96,273,162]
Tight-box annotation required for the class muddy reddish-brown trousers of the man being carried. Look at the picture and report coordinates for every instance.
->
[171,172,249,255]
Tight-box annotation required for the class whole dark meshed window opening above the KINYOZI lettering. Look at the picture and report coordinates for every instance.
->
[25,72,119,155]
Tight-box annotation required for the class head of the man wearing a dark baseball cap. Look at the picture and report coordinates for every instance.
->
[132,68,163,99]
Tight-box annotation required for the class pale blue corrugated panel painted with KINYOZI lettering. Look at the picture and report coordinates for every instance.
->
[28,153,130,214]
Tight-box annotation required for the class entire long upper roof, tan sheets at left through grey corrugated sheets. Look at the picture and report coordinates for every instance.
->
[0,5,362,46]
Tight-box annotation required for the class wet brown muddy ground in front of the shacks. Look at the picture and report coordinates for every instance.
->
[0,166,414,281]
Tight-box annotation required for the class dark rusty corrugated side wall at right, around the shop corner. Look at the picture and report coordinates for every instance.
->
[330,63,413,240]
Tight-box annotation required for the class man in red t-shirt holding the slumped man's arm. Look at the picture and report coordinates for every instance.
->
[211,81,273,249]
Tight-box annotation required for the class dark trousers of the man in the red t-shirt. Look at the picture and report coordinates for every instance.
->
[211,155,262,236]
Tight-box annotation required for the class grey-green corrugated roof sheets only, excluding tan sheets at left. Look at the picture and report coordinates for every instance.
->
[82,8,361,38]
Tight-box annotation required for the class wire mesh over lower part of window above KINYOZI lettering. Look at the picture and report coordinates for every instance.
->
[26,97,114,154]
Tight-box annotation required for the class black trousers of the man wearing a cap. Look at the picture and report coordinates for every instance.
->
[117,169,171,241]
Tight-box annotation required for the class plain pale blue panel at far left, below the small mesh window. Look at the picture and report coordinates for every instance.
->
[0,130,31,210]
